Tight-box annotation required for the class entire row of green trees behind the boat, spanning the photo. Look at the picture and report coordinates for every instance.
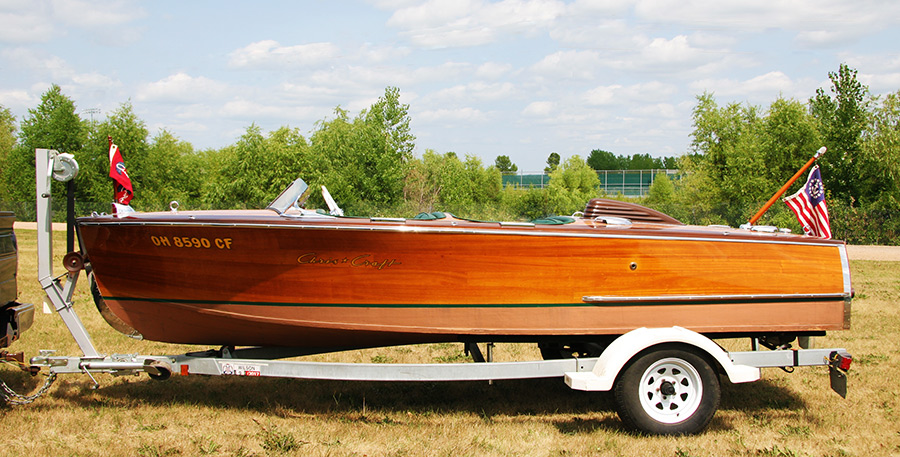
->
[0,65,900,244]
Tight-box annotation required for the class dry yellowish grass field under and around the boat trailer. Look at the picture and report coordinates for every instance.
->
[0,230,900,457]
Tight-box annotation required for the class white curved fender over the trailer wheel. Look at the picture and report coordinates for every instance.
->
[566,327,760,391]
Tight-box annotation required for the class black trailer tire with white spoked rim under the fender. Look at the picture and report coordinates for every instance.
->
[613,346,721,435]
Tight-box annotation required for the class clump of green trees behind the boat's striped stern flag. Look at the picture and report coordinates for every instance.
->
[647,64,900,244]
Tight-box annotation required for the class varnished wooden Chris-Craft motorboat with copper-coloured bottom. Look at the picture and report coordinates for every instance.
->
[77,180,852,350]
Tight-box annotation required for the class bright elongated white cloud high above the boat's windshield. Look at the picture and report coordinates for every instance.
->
[228,40,340,70]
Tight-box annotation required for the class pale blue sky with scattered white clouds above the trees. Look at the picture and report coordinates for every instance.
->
[0,0,900,171]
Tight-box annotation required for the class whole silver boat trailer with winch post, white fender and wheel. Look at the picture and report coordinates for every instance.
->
[21,149,852,434]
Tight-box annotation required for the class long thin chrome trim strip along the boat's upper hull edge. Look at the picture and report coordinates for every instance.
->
[77,219,835,247]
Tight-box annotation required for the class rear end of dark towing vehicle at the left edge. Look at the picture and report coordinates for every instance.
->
[0,211,34,348]
